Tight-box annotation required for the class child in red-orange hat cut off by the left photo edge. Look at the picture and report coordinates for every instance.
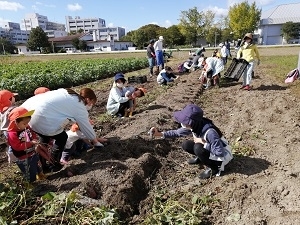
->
[0,90,18,163]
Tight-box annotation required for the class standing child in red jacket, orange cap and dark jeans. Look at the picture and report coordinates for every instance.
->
[7,107,45,182]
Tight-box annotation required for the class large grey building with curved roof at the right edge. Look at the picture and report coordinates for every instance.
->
[255,3,300,45]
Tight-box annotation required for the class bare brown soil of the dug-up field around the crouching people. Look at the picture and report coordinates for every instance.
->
[0,47,300,225]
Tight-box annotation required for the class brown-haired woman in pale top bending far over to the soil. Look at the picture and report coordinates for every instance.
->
[21,88,103,166]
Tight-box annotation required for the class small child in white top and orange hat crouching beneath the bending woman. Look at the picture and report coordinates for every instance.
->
[60,120,107,165]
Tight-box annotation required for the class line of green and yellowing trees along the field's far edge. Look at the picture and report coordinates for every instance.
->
[0,1,300,54]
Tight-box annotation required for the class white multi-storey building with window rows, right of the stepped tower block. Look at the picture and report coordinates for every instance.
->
[66,16,106,33]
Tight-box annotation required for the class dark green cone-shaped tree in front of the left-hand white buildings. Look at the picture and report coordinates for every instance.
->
[27,27,50,52]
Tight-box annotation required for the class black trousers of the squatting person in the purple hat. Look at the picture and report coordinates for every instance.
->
[182,140,222,170]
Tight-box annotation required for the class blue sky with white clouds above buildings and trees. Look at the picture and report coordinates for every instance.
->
[0,0,299,32]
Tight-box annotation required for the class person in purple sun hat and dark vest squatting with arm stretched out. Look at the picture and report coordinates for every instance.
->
[150,104,233,179]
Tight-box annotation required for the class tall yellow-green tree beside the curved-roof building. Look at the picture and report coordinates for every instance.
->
[228,1,261,39]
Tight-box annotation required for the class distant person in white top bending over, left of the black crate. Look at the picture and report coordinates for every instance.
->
[202,57,224,89]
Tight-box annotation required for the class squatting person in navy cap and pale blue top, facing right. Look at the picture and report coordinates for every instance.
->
[106,73,132,117]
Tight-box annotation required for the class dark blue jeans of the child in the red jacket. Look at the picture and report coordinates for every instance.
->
[16,153,42,182]
